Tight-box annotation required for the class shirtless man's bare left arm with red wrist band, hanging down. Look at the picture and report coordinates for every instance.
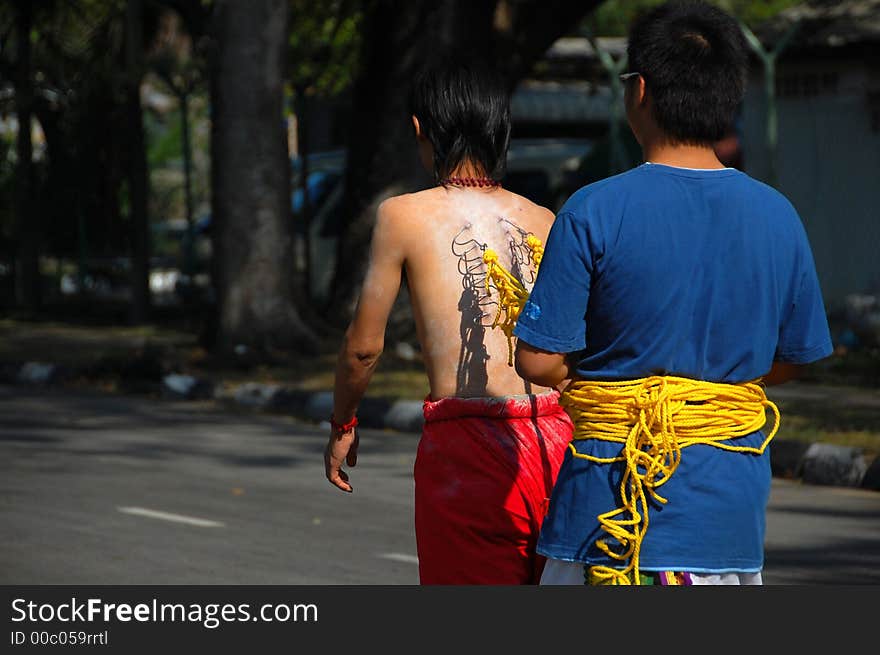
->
[324,202,405,491]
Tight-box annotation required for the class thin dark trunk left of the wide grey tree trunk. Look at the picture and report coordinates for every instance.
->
[125,0,150,324]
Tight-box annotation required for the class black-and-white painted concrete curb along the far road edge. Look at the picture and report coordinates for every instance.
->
[0,362,880,491]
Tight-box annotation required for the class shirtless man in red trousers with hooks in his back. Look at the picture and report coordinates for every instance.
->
[324,63,572,584]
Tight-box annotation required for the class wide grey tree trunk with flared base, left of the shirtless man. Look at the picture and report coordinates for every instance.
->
[210,0,315,354]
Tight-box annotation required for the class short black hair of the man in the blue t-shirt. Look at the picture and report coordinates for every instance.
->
[627,0,748,144]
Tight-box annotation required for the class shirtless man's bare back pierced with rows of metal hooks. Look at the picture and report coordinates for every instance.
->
[383,187,553,399]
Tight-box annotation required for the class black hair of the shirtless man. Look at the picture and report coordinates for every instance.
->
[409,58,510,182]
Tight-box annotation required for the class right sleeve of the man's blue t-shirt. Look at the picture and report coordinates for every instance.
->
[774,230,834,364]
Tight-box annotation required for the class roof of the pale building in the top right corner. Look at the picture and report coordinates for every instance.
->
[755,0,880,50]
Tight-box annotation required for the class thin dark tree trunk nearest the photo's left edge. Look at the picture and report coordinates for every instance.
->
[15,0,41,313]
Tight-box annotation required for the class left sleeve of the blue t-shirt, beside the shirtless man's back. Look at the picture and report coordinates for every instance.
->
[514,213,593,353]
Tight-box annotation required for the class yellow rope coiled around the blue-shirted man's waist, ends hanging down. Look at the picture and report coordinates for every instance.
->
[560,376,780,585]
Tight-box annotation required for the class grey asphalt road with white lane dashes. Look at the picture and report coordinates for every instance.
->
[0,386,880,585]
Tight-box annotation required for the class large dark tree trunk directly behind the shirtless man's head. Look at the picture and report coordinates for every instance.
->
[327,0,601,324]
